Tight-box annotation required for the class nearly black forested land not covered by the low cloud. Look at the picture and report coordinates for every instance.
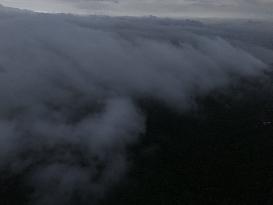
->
[0,73,273,205]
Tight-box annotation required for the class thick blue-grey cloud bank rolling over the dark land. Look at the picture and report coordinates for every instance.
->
[0,8,273,205]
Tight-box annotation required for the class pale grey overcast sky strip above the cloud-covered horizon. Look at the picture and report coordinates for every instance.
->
[0,0,273,18]
